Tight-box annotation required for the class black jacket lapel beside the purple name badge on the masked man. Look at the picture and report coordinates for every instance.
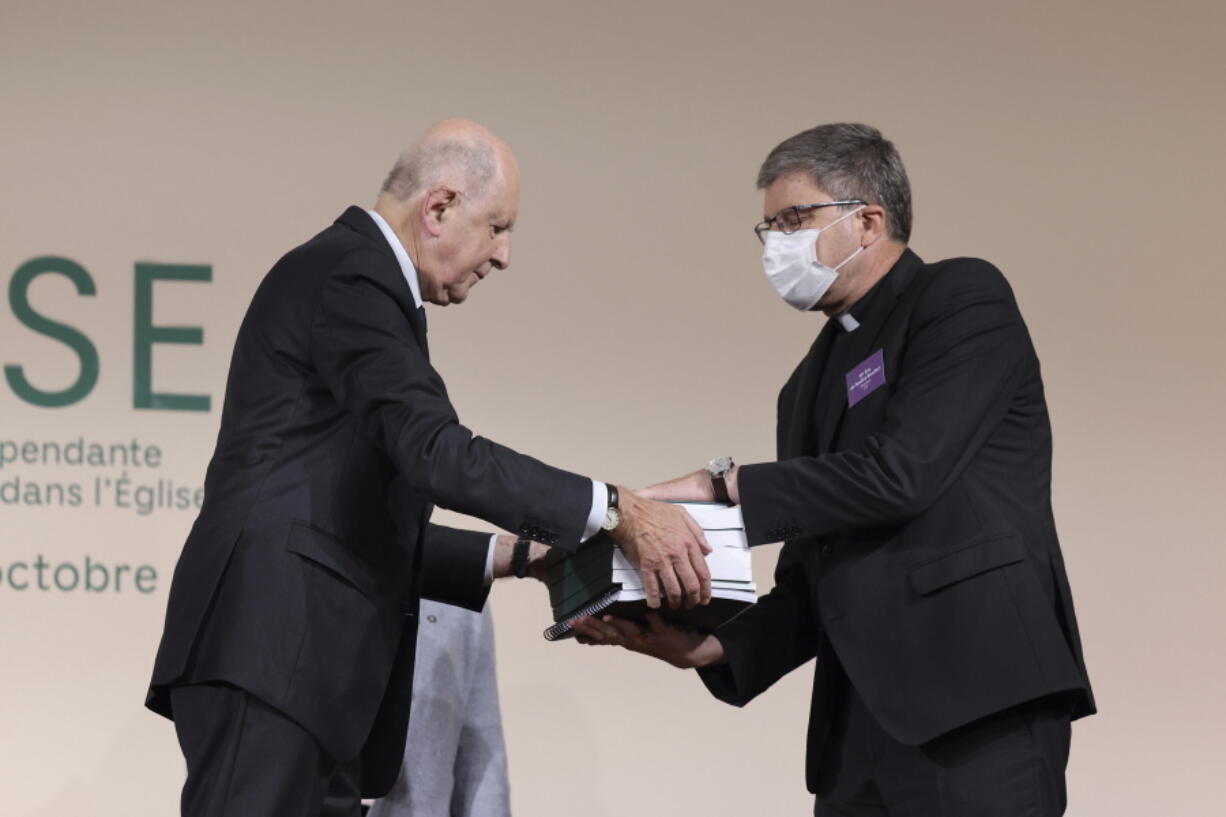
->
[817,249,922,454]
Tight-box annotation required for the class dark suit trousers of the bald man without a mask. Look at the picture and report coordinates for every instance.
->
[170,683,360,817]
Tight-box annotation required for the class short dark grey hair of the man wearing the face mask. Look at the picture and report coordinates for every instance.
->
[758,123,911,244]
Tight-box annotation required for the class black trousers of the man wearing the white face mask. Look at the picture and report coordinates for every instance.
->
[813,689,1070,817]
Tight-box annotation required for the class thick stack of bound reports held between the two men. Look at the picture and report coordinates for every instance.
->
[544,502,758,642]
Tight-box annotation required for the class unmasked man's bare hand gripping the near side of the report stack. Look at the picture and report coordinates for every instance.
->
[609,488,711,610]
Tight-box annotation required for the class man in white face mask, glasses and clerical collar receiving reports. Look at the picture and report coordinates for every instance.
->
[576,124,1095,817]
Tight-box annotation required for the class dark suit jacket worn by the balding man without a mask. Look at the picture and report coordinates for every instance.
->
[148,207,591,795]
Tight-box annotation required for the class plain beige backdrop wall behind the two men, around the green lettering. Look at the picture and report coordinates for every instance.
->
[0,0,1226,817]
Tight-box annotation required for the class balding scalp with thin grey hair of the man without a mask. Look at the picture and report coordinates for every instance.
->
[380,119,519,202]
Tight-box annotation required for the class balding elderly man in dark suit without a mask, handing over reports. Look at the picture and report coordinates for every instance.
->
[147,120,710,817]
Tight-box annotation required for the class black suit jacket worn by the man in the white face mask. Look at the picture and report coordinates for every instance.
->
[701,250,1094,791]
